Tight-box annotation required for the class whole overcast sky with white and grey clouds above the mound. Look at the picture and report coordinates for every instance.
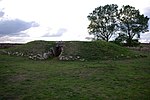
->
[0,0,150,42]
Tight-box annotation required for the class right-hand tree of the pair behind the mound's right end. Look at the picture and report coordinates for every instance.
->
[118,5,149,46]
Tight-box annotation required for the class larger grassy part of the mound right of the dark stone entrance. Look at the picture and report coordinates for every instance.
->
[61,41,141,60]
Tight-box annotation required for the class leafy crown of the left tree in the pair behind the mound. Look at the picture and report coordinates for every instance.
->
[88,4,118,41]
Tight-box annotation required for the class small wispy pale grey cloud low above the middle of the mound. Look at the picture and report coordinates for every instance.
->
[43,28,67,37]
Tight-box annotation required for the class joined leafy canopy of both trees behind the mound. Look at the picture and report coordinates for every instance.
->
[88,4,149,46]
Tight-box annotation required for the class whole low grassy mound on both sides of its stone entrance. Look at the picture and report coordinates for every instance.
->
[3,41,144,61]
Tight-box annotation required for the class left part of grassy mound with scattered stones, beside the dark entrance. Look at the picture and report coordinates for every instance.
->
[0,41,56,60]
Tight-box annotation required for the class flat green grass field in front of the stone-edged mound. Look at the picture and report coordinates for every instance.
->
[0,51,150,100]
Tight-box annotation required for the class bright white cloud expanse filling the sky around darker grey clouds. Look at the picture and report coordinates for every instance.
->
[0,0,150,42]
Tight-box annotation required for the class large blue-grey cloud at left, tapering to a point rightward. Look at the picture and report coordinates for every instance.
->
[0,19,39,36]
